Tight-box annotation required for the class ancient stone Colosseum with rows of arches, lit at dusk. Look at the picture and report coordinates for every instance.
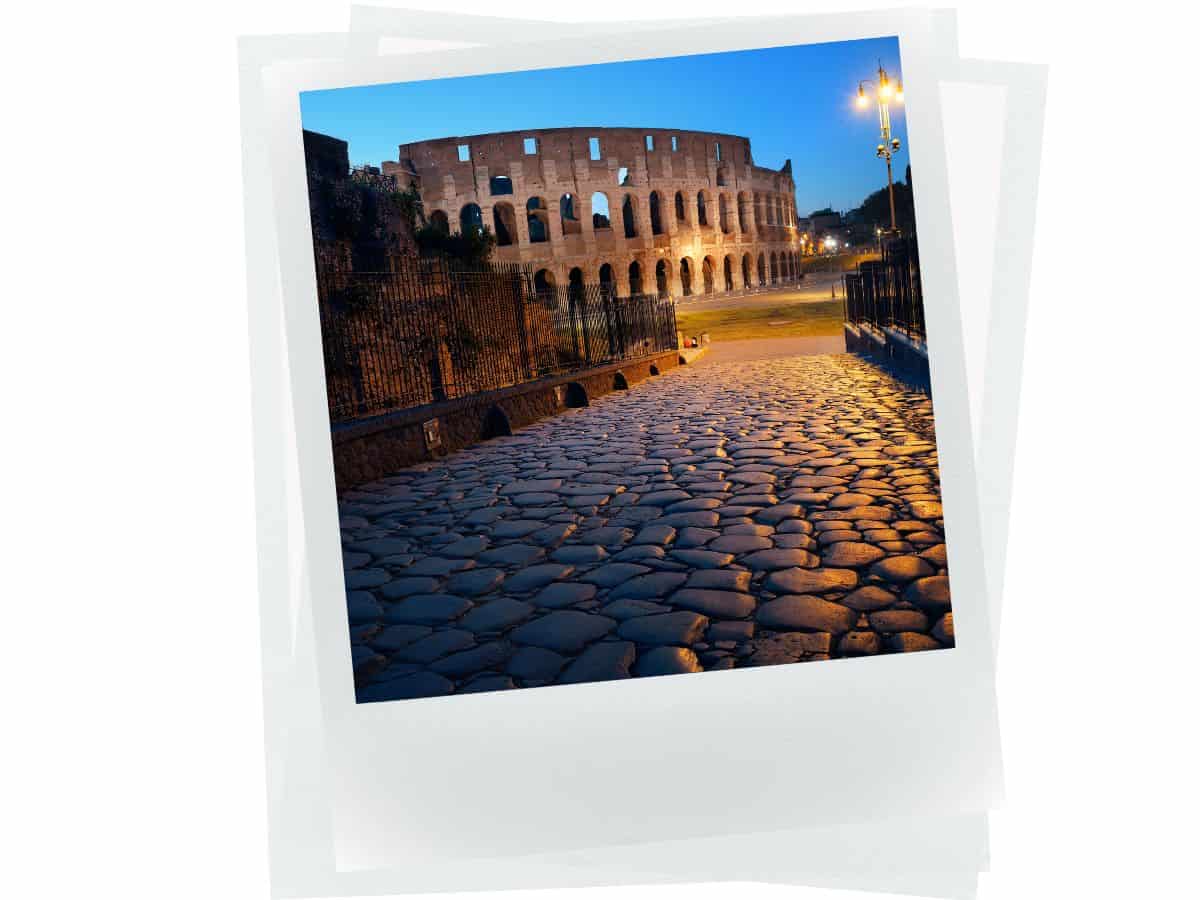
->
[383,128,800,298]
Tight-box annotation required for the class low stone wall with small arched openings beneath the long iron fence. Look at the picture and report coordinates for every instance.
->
[332,350,683,493]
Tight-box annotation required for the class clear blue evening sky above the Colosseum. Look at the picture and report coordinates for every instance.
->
[300,37,908,215]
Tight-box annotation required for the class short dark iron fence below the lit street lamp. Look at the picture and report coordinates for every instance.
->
[841,238,925,341]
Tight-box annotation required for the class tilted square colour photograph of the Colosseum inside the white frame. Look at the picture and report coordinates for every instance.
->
[298,37,954,703]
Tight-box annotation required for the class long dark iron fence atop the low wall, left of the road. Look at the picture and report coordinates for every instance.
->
[318,258,677,424]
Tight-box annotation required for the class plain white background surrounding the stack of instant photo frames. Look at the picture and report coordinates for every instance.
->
[0,0,1200,900]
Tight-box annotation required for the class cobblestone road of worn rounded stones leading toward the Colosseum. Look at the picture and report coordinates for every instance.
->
[341,355,954,701]
